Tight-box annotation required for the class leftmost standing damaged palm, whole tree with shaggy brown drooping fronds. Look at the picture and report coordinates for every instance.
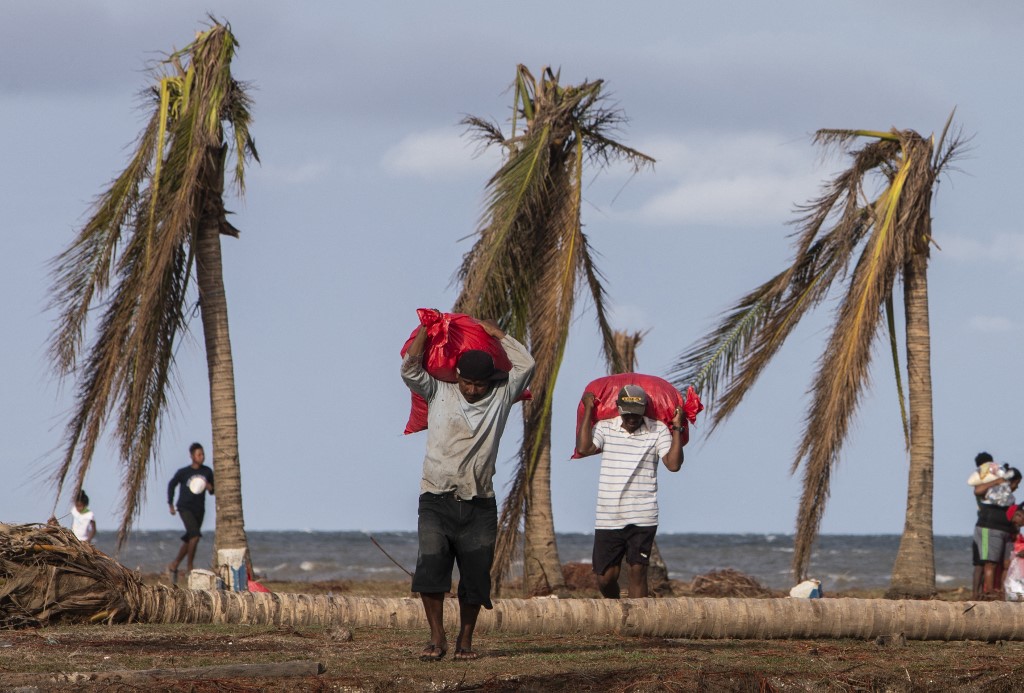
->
[49,24,257,551]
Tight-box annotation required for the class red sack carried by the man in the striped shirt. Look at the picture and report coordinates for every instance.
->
[572,373,703,459]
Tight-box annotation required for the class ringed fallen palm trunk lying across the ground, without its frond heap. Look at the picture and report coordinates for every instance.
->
[121,586,1024,642]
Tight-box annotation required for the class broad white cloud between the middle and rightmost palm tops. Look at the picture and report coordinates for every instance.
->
[640,132,824,226]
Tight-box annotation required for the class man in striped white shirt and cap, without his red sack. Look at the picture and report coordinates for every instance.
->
[577,385,685,599]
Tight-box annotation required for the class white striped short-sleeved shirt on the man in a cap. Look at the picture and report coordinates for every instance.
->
[594,417,672,529]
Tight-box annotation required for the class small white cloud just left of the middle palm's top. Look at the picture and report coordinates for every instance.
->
[381,129,501,179]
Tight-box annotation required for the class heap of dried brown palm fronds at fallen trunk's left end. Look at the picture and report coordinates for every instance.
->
[0,524,146,627]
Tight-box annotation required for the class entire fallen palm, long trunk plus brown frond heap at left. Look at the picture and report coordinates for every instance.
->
[6,525,1024,641]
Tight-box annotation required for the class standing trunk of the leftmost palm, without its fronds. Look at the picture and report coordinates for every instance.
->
[196,149,249,565]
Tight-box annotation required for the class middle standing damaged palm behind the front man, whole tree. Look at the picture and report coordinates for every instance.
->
[455,66,654,595]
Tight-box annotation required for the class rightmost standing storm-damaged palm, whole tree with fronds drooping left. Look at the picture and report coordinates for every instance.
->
[673,115,963,597]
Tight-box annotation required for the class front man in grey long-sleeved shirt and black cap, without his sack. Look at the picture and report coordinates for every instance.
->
[401,320,534,661]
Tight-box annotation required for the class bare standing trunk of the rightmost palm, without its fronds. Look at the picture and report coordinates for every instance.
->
[887,247,935,598]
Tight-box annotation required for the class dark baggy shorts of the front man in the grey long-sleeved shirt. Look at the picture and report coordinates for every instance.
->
[413,493,498,609]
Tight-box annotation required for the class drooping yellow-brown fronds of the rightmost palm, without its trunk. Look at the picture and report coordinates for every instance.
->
[672,123,961,578]
